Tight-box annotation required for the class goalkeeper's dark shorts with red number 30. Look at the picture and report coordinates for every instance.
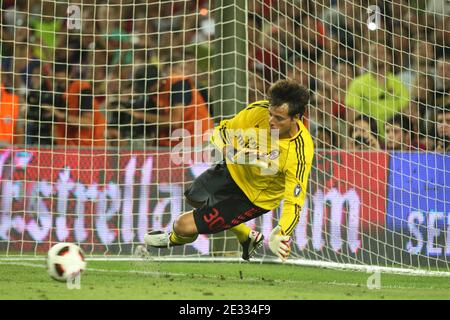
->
[184,163,268,234]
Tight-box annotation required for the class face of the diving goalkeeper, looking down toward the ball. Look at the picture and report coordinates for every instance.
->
[269,103,298,139]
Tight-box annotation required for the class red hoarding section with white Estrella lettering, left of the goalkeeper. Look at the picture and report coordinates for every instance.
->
[0,149,190,252]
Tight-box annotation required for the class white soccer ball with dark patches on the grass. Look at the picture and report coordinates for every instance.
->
[47,242,86,281]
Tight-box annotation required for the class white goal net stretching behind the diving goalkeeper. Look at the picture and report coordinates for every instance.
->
[0,0,450,272]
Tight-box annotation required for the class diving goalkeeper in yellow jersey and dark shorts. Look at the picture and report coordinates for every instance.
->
[144,80,314,261]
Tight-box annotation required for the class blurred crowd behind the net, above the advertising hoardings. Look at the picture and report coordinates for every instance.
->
[0,0,450,152]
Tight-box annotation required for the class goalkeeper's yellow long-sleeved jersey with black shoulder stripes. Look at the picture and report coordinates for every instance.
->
[211,100,314,235]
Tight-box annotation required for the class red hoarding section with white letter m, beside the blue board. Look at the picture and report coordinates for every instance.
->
[295,151,389,253]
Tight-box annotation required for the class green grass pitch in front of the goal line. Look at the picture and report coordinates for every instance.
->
[0,260,450,300]
